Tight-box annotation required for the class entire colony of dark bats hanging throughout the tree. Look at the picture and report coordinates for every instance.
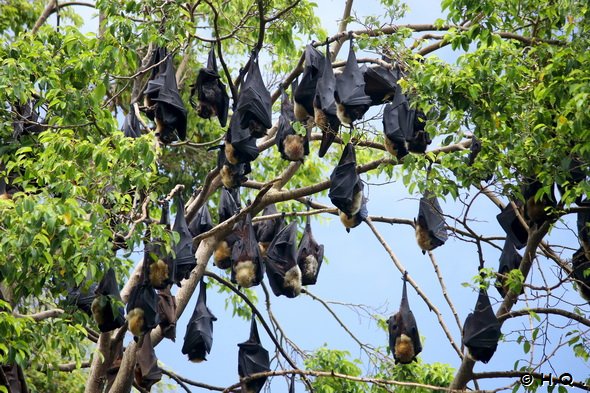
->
[49,35,590,392]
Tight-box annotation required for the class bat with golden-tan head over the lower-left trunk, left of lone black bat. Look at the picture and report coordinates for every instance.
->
[127,282,160,337]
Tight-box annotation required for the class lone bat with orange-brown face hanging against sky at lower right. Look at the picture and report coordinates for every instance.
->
[387,273,422,364]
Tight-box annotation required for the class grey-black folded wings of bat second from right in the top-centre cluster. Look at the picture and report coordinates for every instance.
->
[335,40,371,109]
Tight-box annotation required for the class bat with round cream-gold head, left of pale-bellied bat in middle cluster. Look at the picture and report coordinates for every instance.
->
[231,213,264,288]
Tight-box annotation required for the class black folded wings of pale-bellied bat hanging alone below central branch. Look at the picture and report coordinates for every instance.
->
[328,143,362,213]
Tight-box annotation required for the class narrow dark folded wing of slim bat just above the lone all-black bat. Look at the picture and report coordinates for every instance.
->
[172,196,197,284]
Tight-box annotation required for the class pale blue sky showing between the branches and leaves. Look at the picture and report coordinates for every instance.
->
[67,0,590,392]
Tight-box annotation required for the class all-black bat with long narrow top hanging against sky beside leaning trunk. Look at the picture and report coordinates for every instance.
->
[182,280,217,363]
